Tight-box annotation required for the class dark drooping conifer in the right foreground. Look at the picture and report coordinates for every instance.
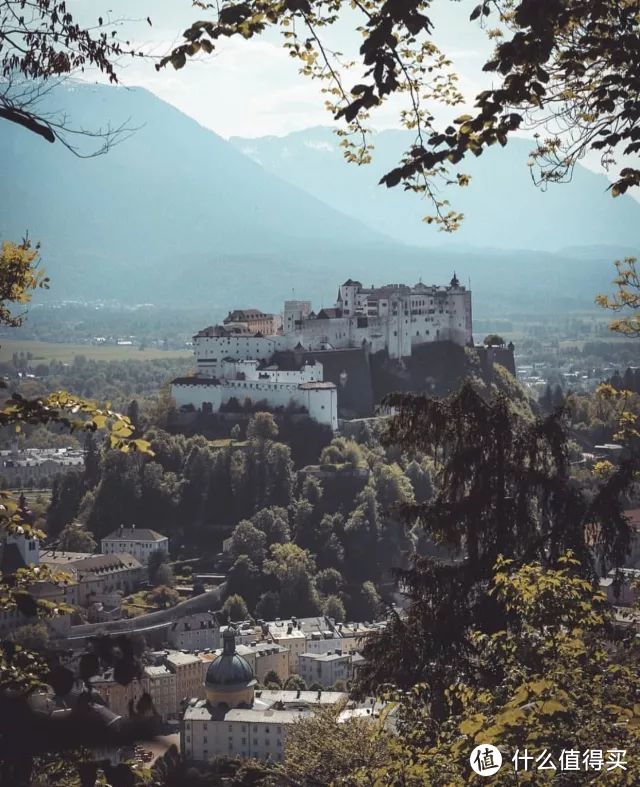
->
[360,383,633,715]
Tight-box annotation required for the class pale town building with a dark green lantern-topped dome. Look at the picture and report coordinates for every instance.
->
[180,629,347,762]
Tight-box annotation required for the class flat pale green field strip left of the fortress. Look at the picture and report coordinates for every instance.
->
[0,339,193,364]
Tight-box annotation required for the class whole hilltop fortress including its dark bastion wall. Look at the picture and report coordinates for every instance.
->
[171,274,512,430]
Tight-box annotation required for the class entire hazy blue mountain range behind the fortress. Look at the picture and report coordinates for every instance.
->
[0,83,640,314]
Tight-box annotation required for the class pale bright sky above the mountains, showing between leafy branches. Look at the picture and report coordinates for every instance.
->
[69,0,490,137]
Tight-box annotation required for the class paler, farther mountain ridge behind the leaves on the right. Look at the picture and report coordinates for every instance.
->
[230,126,640,251]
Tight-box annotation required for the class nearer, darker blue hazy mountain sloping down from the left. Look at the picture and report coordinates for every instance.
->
[0,83,395,304]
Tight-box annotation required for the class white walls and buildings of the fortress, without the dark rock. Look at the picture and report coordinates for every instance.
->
[171,273,473,430]
